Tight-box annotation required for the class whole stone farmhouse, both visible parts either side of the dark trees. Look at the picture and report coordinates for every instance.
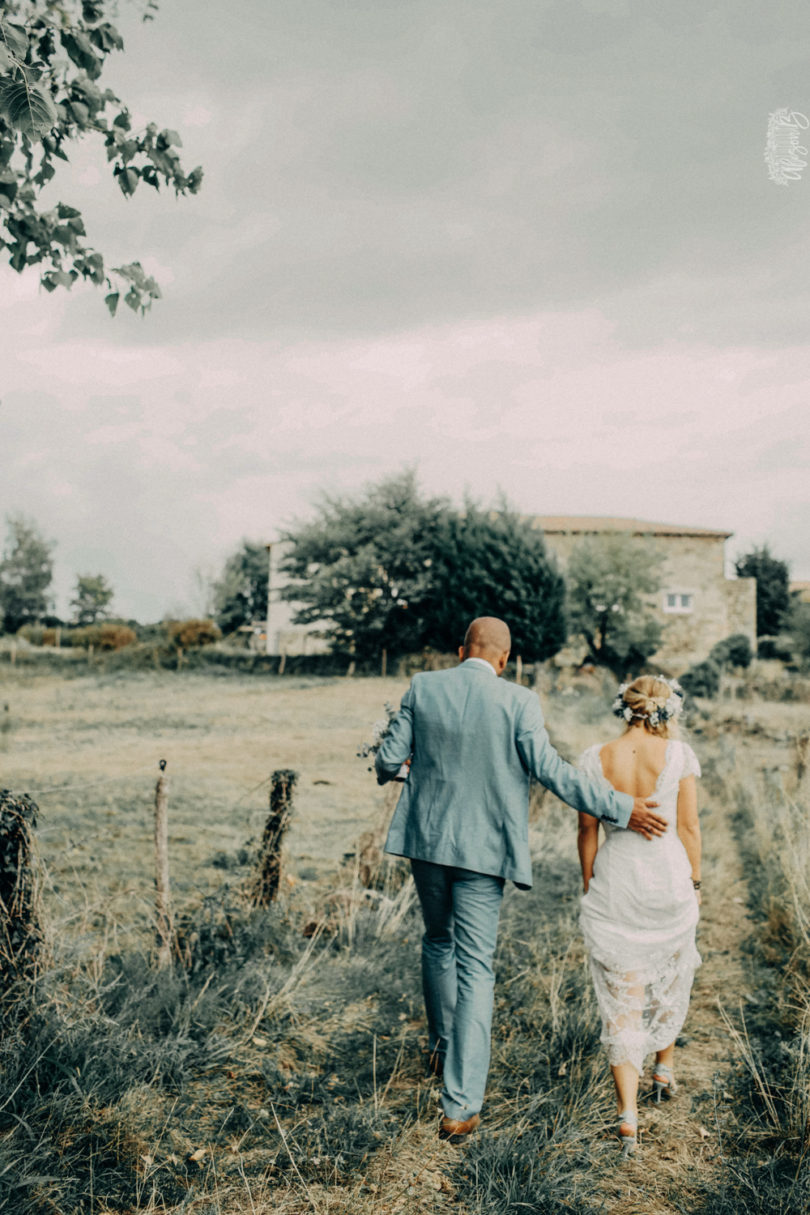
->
[261,515,757,674]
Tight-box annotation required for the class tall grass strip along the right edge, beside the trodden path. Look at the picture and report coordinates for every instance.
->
[699,747,810,1215]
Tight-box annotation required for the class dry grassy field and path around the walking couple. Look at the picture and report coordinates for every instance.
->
[0,668,810,1215]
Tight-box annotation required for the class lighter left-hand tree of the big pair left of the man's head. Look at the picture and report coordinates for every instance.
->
[282,471,448,661]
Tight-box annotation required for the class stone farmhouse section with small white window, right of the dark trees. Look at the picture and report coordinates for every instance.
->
[527,515,757,673]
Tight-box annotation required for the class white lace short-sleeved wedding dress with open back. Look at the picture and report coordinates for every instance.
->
[579,739,701,1074]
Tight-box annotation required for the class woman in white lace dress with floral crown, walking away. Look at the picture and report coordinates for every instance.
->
[578,676,701,1155]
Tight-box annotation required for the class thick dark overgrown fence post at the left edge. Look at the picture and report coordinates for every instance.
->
[0,789,43,995]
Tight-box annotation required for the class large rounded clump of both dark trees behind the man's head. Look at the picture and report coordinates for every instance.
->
[283,471,565,661]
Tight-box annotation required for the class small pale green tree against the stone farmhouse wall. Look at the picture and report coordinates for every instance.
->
[567,535,662,678]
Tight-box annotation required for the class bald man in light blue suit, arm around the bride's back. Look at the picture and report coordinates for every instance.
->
[375,616,667,1142]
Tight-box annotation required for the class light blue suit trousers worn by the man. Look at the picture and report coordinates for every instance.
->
[410,860,504,1120]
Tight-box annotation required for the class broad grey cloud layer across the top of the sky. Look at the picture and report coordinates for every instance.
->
[45,0,810,345]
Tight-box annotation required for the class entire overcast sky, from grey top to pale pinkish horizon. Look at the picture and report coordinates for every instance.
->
[0,0,810,620]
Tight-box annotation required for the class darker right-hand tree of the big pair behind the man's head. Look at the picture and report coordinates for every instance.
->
[424,502,566,662]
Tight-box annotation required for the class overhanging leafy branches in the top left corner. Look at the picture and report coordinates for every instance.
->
[0,0,203,315]
